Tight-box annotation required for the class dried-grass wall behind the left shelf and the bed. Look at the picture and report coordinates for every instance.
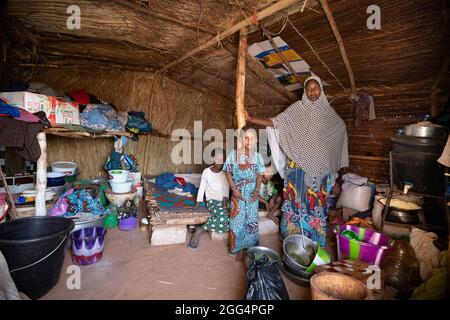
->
[27,69,233,178]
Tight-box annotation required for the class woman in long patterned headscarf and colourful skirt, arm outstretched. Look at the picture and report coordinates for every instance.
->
[246,76,349,246]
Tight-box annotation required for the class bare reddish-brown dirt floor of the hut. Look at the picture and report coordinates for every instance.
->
[42,229,310,300]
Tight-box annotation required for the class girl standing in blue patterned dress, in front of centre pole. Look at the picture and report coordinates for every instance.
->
[223,126,264,260]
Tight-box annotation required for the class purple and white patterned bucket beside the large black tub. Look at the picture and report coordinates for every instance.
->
[70,227,106,265]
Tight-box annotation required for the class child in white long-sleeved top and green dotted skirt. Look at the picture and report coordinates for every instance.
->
[188,149,230,250]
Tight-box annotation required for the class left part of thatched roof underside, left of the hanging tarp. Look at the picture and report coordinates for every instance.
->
[0,0,306,105]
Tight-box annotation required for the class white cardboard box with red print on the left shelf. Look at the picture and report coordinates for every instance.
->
[0,91,80,126]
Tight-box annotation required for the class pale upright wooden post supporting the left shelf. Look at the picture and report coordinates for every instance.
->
[35,132,47,217]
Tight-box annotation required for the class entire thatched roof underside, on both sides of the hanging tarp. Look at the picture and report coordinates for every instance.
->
[1,0,449,105]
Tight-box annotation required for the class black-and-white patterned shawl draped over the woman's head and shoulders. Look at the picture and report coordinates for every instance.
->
[271,76,349,177]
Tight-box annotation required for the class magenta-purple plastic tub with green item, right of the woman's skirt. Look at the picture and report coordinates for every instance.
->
[334,225,391,267]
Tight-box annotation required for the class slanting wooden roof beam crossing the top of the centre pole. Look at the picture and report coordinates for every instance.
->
[160,0,300,72]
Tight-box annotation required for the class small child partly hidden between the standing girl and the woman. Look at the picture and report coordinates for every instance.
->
[259,164,283,224]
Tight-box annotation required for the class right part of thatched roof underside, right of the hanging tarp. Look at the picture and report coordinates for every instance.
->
[249,0,450,92]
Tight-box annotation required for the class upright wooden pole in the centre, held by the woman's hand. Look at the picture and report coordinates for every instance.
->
[236,28,247,129]
